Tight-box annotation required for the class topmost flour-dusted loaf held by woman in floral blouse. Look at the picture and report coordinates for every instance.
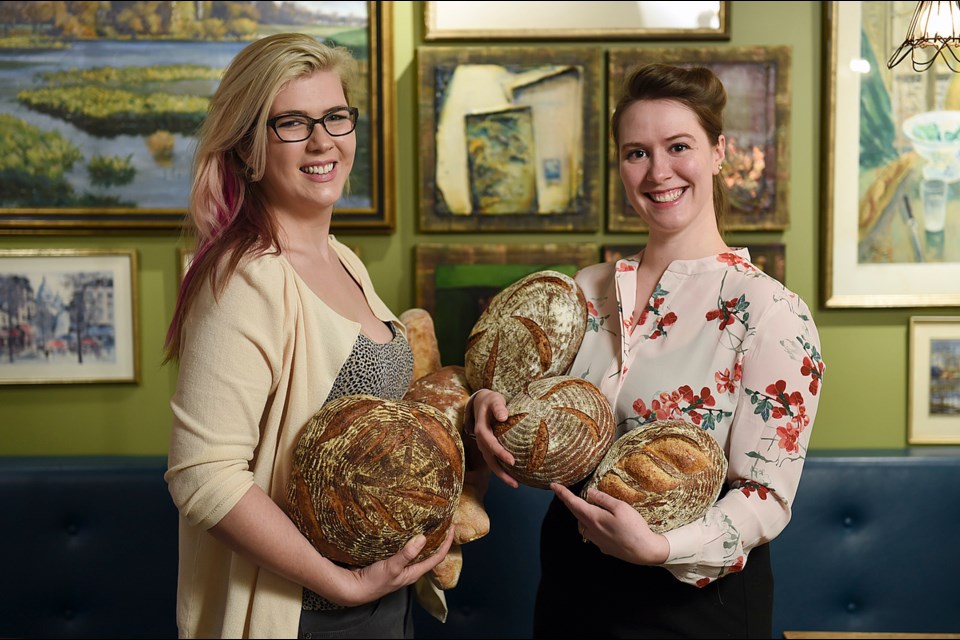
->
[464,270,587,400]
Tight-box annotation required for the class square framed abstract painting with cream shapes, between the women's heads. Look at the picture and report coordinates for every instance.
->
[417,47,602,232]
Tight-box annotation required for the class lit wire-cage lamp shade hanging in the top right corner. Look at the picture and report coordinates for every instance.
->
[887,2,960,73]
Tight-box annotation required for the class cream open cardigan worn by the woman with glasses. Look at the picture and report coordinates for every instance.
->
[166,237,405,638]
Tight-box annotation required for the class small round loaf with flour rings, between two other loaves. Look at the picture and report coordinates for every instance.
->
[493,376,616,489]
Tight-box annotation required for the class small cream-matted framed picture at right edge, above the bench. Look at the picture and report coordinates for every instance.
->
[907,316,960,444]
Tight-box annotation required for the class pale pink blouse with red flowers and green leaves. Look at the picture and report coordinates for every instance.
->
[570,249,824,586]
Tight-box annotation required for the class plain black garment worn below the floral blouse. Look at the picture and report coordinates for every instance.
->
[533,488,773,638]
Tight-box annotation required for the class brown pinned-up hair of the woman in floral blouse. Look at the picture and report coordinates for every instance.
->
[610,63,730,234]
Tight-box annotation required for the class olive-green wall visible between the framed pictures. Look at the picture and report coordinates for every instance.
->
[0,2,957,455]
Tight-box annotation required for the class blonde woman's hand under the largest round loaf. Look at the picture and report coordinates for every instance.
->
[340,525,454,606]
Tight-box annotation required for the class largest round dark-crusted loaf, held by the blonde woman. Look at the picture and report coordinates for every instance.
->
[287,395,464,566]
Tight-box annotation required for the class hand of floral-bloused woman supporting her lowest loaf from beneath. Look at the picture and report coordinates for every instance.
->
[550,482,670,565]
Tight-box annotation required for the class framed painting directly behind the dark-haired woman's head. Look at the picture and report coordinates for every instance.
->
[607,47,791,232]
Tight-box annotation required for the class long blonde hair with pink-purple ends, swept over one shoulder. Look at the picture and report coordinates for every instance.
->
[164,33,357,361]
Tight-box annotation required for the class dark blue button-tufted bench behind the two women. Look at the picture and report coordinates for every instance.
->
[0,448,960,638]
